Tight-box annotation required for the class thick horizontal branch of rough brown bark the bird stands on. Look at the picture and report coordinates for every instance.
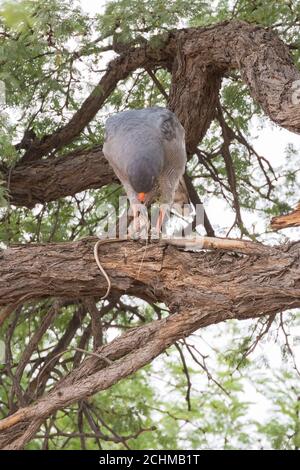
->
[0,238,300,310]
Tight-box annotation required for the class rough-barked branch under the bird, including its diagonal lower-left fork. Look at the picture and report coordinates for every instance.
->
[0,239,300,449]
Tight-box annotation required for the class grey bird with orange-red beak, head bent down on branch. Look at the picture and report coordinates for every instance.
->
[103,107,187,231]
